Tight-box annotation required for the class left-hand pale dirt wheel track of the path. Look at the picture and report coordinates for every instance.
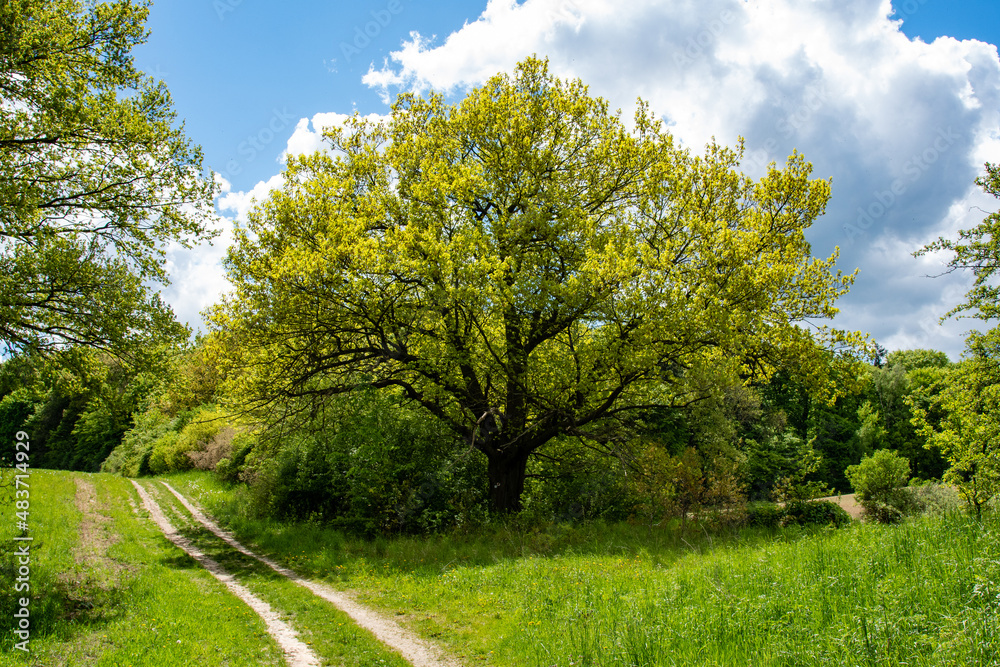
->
[132,480,320,667]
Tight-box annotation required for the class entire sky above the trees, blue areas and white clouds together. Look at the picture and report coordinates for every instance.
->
[136,0,1000,358]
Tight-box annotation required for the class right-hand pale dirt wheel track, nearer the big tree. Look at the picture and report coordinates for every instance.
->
[160,481,461,667]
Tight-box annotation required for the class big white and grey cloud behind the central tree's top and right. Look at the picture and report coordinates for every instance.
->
[364,0,1000,358]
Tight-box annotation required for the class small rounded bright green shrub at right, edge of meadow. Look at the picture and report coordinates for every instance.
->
[844,449,916,523]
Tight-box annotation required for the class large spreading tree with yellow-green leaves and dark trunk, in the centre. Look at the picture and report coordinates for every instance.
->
[212,58,853,511]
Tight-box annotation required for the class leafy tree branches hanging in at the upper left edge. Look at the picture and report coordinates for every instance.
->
[0,0,213,358]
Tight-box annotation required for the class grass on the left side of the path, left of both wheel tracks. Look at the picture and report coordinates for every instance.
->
[0,470,283,666]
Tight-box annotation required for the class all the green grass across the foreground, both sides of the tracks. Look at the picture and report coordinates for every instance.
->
[0,471,1000,667]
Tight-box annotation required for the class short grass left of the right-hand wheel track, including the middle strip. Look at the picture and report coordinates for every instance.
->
[0,470,406,667]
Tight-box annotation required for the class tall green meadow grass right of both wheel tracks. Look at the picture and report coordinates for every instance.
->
[175,475,1000,667]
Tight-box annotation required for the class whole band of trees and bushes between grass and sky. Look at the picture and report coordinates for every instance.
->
[0,0,1000,532]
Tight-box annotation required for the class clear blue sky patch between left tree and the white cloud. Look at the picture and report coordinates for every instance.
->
[136,0,478,190]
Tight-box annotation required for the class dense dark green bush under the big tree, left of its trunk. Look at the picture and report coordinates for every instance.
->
[240,393,485,535]
